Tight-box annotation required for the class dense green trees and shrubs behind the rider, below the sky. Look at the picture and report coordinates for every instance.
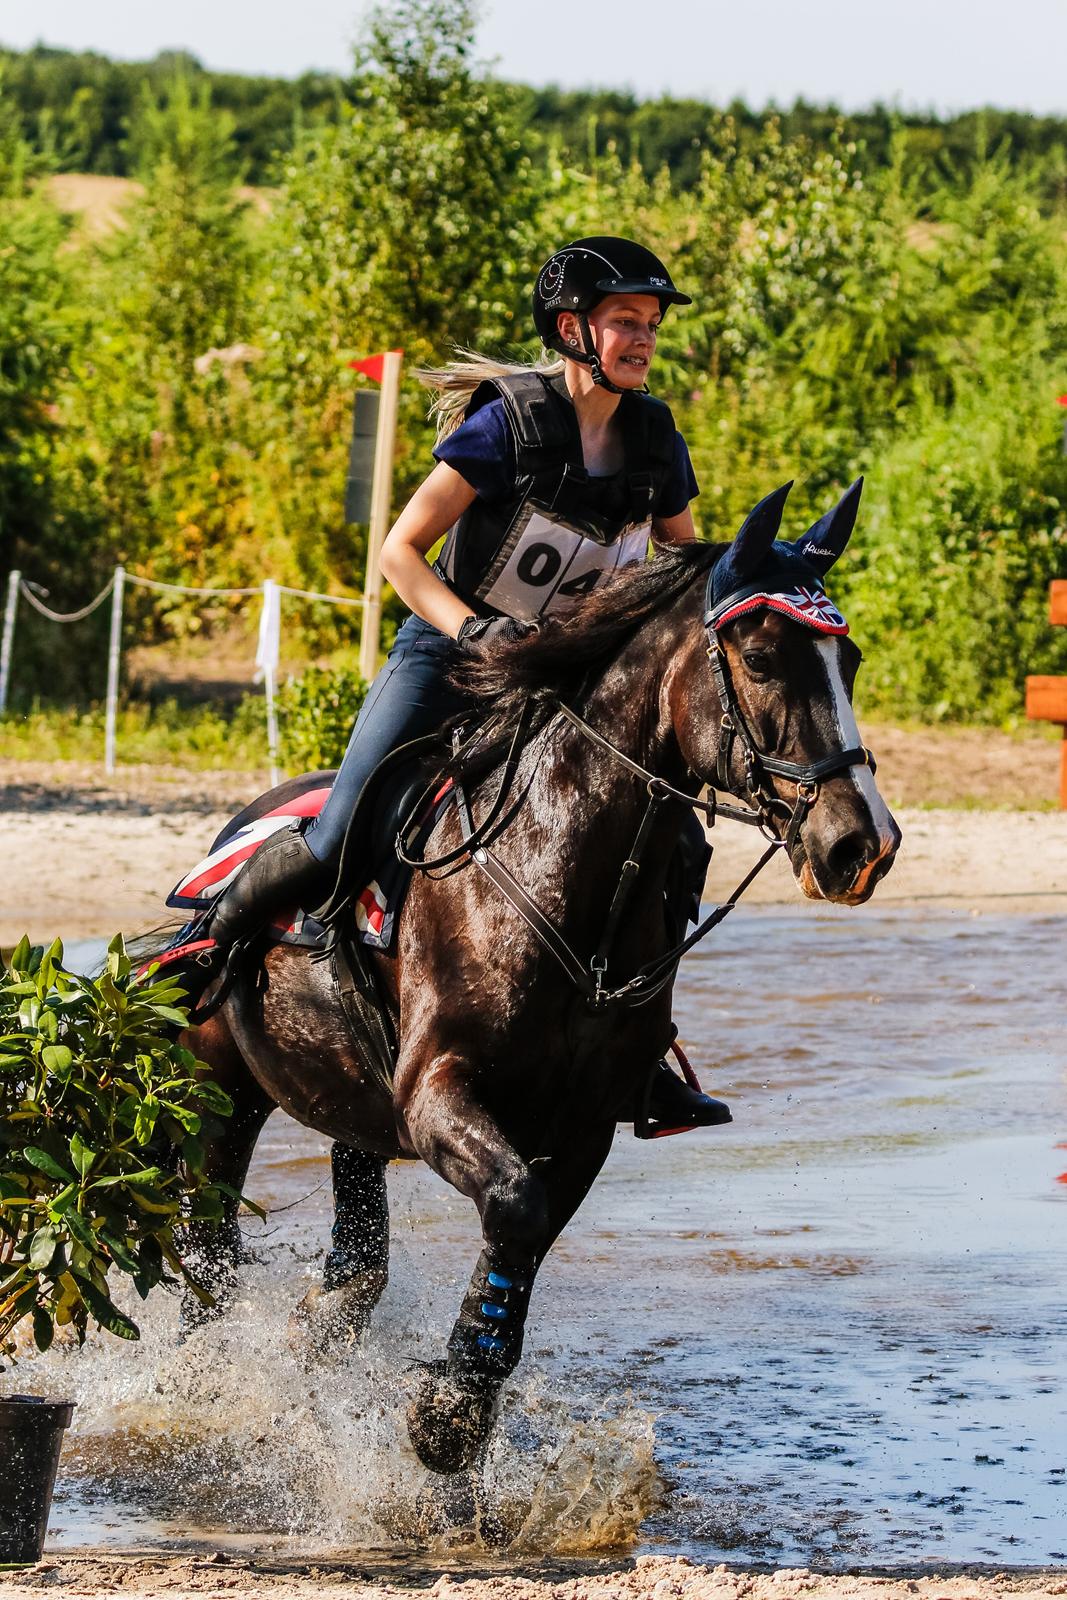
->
[0,0,1067,720]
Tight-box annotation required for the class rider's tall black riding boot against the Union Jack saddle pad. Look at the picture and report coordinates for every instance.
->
[146,822,330,1022]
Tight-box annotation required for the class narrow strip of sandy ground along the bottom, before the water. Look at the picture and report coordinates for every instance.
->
[0,1552,1067,1600]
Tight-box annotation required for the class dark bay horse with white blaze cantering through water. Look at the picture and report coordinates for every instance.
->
[181,493,899,1472]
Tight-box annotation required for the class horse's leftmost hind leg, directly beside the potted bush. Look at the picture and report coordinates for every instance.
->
[182,1013,274,1330]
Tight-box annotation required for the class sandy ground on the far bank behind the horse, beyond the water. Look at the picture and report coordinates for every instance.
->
[0,726,1067,946]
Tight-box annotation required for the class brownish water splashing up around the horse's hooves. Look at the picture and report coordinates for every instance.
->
[5,1251,659,1554]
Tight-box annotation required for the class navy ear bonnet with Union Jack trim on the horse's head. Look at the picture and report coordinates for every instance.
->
[704,478,864,634]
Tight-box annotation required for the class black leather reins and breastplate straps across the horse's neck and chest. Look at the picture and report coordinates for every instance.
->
[397,573,875,1011]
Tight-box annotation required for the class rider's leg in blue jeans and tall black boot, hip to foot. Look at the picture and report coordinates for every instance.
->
[153,618,462,1010]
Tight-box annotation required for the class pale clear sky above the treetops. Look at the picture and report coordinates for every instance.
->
[0,0,1067,115]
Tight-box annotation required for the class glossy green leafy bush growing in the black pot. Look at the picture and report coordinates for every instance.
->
[0,938,252,1355]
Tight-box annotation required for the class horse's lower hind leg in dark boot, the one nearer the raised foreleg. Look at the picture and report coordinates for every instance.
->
[298,1144,389,1349]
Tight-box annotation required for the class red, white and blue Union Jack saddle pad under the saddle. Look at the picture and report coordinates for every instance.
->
[166,773,398,950]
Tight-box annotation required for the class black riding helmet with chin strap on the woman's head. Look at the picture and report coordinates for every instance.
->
[533,234,693,394]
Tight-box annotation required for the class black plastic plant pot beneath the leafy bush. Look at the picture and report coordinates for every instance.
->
[0,1395,74,1563]
